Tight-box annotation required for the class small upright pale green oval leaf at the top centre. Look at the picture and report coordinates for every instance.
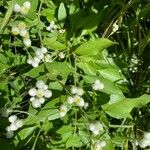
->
[58,3,67,27]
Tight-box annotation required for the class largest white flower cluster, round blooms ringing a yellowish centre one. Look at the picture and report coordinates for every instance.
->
[29,80,52,108]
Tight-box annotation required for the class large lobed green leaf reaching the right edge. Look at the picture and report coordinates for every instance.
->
[102,95,150,119]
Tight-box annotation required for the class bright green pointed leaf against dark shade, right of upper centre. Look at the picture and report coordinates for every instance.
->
[75,38,115,56]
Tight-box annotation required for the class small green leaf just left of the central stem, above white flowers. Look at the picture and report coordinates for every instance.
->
[43,37,67,50]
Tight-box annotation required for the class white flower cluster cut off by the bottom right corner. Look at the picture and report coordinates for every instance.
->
[138,132,150,148]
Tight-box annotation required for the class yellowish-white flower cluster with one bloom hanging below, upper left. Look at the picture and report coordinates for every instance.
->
[11,22,31,47]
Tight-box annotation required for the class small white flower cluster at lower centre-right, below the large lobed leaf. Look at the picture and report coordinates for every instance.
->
[89,121,103,136]
